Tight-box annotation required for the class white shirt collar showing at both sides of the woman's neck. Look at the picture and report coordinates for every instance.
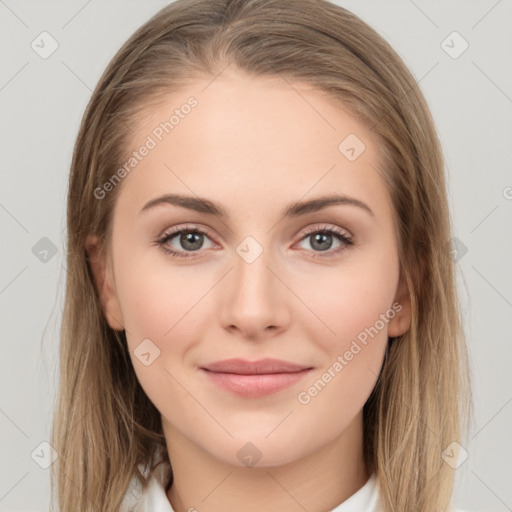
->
[120,464,464,512]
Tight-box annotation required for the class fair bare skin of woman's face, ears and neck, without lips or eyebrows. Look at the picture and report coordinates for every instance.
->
[87,71,410,512]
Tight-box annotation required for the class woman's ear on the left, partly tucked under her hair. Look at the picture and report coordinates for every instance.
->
[85,235,125,331]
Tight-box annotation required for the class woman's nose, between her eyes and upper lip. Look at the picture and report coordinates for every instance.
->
[220,246,290,341]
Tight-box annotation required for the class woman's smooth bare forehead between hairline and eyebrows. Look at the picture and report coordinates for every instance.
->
[113,74,389,222]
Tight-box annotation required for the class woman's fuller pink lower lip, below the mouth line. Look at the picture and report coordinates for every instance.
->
[202,368,311,398]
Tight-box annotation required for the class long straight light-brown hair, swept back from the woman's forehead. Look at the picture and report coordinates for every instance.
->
[51,0,472,512]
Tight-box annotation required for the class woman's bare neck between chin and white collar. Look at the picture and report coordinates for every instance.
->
[164,411,369,512]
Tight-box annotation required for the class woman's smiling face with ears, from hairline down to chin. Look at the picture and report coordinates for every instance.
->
[88,73,409,466]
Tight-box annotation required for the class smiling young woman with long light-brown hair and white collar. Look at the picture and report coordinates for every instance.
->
[53,0,470,512]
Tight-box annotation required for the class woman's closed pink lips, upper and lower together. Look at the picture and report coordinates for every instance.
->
[200,358,312,398]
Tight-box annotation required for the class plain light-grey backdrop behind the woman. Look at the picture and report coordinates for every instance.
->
[0,0,512,512]
